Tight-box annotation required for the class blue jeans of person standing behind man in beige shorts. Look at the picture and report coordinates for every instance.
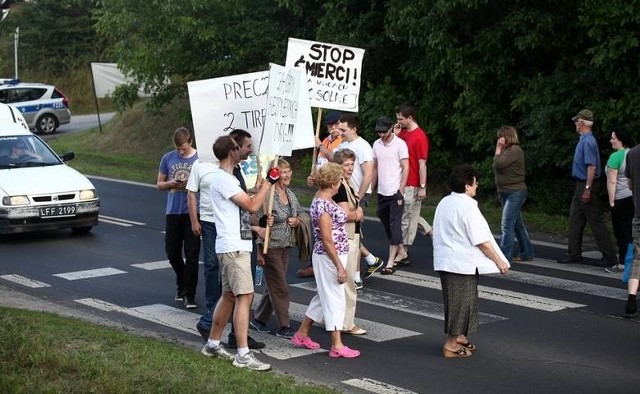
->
[198,220,222,327]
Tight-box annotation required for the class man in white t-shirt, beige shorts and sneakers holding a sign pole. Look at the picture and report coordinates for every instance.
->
[201,136,279,371]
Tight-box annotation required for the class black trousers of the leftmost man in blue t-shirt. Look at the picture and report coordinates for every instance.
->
[165,214,200,298]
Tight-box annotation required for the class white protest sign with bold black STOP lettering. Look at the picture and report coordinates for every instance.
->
[286,38,364,112]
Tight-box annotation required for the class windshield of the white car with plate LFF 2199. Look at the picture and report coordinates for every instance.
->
[0,135,62,168]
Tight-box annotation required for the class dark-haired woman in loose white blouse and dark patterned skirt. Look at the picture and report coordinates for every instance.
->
[433,164,509,358]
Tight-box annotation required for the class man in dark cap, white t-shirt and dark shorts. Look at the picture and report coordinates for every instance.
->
[371,116,409,275]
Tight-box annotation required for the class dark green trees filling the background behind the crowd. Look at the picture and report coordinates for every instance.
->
[7,0,640,213]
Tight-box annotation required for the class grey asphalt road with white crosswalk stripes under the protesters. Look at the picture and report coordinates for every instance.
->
[0,178,640,393]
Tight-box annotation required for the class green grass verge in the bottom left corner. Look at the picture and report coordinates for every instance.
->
[0,308,335,394]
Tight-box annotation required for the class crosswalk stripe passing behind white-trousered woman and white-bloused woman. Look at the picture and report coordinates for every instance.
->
[290,284,508,324]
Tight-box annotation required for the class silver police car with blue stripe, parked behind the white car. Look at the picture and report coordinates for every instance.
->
[0,79,71,134]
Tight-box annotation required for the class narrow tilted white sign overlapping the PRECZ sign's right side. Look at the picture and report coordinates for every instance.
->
[260,63,314,156]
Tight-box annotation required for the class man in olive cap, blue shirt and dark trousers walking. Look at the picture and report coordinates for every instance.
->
[558,109,617,266]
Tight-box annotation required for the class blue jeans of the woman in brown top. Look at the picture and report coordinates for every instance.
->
[500,190,534,262]
